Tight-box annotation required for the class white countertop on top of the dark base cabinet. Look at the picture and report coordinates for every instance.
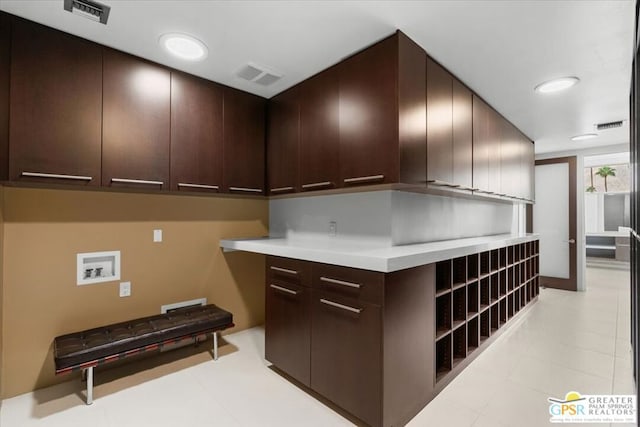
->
[220,234,539,273]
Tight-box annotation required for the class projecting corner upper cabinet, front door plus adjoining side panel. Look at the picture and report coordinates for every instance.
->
[339,32,426,187]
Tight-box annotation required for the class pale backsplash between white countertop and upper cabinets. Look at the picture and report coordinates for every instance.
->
[269,190,519,246]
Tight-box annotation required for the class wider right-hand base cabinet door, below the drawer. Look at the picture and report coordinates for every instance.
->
[311,289,382,426]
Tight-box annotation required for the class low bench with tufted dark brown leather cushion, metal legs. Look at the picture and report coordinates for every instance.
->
[53,304,234,404]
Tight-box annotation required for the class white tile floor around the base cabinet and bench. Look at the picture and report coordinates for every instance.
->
[0,268,634,427]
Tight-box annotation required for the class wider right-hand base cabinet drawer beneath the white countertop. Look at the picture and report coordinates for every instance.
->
[313,264,384,304]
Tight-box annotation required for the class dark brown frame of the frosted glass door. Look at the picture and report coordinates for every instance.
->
[527,156,578,291]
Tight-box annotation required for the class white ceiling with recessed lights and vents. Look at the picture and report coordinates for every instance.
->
[0,0,635,153]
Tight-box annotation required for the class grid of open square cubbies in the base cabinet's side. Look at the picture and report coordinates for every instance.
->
[434,240,540,383]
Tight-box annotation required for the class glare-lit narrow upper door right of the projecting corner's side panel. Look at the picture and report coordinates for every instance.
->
[427,58,454,185]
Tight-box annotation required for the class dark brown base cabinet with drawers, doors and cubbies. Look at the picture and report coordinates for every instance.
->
[265,241,539,426]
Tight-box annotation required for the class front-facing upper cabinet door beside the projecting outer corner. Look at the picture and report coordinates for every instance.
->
[339,37,399,186]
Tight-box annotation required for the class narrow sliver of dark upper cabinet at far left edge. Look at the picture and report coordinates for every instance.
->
[0,12,11,180]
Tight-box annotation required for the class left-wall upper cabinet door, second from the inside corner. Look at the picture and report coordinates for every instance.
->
[171,72,222,192]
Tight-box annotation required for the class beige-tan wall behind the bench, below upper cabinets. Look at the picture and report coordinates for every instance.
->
[0,187,268,398]
